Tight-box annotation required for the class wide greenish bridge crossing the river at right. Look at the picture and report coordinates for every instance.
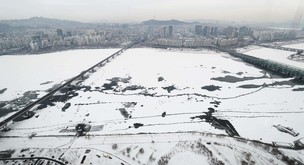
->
[213,46,304,81]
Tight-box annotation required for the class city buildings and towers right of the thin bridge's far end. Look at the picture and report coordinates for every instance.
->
[154,25,304,47]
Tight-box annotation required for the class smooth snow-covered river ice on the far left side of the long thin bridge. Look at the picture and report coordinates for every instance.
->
[0,49,118,101]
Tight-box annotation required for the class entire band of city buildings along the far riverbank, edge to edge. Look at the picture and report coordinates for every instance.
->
[0,21,304,54]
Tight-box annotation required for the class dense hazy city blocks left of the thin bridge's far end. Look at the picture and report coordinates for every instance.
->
[0,27,143,54]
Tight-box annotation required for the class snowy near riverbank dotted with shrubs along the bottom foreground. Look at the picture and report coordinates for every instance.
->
[0,133,294,165]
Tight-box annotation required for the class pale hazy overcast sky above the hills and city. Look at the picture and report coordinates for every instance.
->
[0,0,304,22]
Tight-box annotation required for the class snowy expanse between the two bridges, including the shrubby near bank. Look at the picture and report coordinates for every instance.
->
[0,48,304,164]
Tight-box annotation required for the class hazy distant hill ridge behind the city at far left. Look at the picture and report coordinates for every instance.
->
[0,17,89,28]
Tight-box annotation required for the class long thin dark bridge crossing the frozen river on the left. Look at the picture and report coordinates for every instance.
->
[0,44,133,130]
